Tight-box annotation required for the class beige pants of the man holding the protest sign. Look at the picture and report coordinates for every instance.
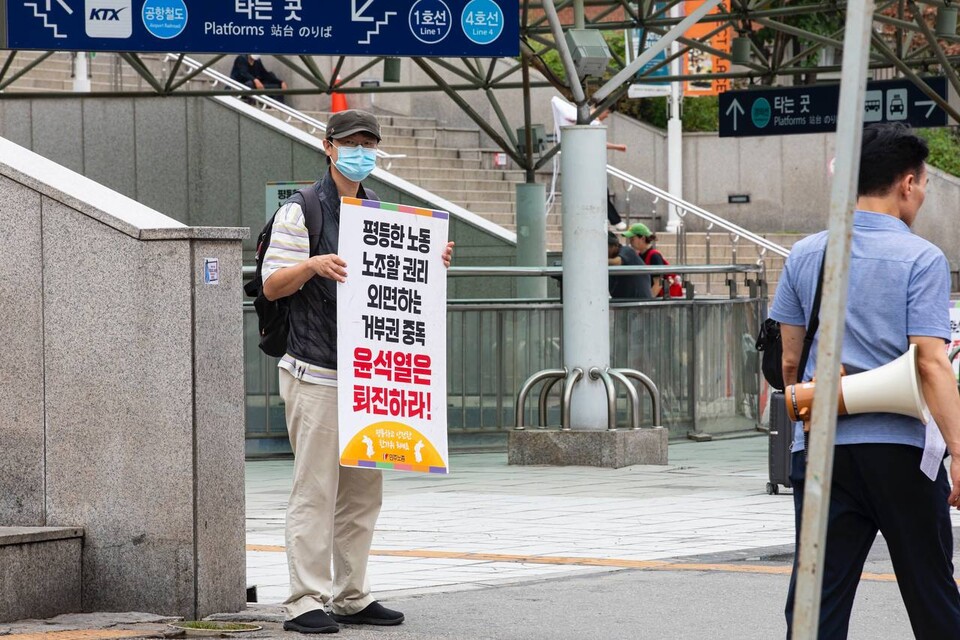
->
[280,369,383,618]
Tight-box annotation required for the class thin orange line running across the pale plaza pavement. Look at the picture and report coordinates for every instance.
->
[244,544,912,584]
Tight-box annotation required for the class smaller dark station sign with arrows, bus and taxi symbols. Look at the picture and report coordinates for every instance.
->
[720,77,947,138]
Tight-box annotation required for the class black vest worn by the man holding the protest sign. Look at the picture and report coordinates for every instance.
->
[287,171,379,369]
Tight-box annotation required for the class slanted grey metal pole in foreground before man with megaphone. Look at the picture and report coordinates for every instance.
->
[793,0,874,640]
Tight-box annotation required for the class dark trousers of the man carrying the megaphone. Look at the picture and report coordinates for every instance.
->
[786,444,960,640]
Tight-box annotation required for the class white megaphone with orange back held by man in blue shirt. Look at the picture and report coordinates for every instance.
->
[784,344,930,429]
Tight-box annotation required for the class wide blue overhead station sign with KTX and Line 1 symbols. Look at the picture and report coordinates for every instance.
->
[0,0,520,57]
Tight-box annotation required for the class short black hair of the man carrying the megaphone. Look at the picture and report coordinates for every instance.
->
[857,122,930,197]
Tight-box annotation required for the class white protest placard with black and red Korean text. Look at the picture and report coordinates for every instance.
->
[337,198,450,473]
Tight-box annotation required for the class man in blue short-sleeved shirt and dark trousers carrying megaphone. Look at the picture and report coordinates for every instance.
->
[770,124,960,640]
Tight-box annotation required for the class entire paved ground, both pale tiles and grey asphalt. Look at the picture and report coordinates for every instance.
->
[7,437,960,640]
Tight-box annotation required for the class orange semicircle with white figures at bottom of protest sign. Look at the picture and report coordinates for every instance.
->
[340,421,447,473]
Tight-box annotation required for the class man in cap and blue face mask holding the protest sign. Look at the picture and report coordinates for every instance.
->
[262,110,453,633]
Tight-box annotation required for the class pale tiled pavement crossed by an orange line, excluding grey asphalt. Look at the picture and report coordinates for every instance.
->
[247,436,808,603]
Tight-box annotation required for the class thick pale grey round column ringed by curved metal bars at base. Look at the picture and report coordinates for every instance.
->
[560,125,610,429]
